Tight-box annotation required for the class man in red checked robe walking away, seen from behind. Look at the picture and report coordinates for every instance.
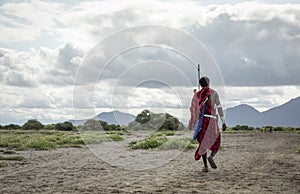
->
[189,77,226,172]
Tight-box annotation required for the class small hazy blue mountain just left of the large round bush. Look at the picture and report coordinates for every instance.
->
[93,111,135,125]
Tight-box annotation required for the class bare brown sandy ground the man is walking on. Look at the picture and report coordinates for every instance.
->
[0,133,300,193]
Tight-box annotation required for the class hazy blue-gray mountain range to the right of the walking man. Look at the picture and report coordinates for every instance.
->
[226,97,300,127]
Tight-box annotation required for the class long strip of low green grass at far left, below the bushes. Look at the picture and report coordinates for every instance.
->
[0,130,123,152]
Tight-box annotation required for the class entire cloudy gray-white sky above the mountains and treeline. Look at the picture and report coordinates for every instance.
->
[0,0,300,125]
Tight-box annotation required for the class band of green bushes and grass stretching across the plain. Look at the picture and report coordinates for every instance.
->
[0,110,300,154]
